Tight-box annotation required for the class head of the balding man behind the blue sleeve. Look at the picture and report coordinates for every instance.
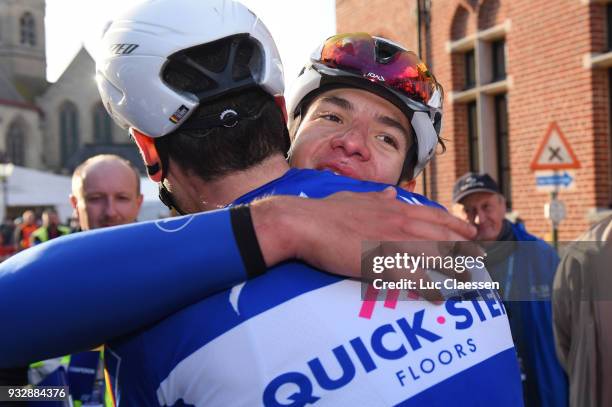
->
[70,154,143,230]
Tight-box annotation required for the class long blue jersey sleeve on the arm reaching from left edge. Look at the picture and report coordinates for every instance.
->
[0,209,252,368]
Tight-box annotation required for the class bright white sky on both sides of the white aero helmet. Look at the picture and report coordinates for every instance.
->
[45,0,336,84]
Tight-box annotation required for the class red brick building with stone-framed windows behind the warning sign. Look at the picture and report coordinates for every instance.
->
[336,0,612,240]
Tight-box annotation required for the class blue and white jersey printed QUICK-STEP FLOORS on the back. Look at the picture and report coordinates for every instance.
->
[105,170,522,407]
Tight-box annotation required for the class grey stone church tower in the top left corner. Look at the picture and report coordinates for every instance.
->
[0,0,47,101]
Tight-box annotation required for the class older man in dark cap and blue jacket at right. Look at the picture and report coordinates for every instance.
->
[453,172,567,407]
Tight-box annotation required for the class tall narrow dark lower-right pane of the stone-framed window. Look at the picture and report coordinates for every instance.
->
[494,94,512,209]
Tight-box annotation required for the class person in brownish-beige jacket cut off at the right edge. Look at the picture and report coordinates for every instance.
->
[552,216,612,407]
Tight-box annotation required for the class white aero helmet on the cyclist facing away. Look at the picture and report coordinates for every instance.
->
[96,0,284,138]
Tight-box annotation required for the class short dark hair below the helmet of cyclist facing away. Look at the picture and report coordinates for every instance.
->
[155,89,289,181]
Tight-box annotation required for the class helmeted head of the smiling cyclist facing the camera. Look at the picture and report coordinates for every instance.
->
[288,33,444,191]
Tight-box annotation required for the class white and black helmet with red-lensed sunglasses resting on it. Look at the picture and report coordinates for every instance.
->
[287,33,444,179]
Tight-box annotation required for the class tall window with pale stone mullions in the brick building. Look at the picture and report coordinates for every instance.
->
[448,0,510,191]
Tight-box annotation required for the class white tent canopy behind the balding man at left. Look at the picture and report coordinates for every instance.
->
[0,164,168,220]
